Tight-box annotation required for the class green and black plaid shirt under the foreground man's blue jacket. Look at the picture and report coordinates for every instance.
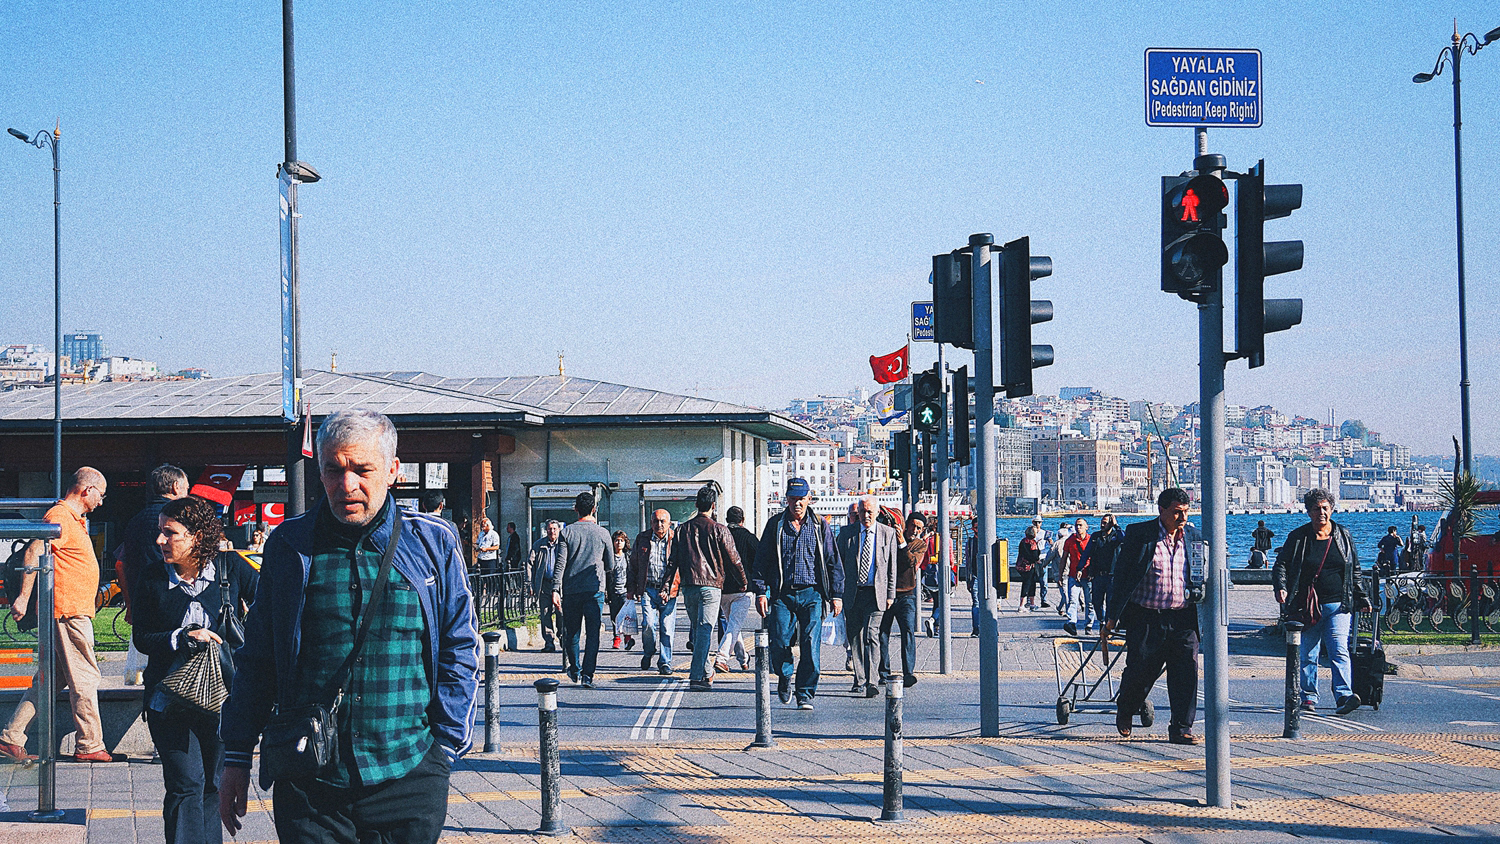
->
[297,499,434,786]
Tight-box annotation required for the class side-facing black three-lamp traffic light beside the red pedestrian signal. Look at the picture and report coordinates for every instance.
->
[1235,159,1302,369]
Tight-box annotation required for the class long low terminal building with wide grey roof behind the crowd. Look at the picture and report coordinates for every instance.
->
[0,370,816,559]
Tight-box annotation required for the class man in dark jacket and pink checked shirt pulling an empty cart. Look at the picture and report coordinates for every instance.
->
[1100,487,1202,745]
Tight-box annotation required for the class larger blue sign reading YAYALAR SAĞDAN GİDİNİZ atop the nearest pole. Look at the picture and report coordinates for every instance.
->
[1146,46,1262,129]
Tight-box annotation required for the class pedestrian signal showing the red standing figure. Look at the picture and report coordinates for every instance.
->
[1161,172,1229,301]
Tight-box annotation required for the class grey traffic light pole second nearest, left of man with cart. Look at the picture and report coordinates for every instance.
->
[969,234,1001,738]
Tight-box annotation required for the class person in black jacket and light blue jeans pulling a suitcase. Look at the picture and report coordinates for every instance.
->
[1271,489,1371,715]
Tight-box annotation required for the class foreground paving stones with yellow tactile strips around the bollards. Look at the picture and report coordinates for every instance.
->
[0,733,1500,844]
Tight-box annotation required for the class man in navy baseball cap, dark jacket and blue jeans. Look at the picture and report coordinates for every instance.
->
[750,478,845,711]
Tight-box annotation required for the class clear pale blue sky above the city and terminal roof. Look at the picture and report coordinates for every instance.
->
[0,0,1500,454]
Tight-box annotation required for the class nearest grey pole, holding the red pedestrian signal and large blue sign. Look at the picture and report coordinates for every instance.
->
[1194,137,1230,808]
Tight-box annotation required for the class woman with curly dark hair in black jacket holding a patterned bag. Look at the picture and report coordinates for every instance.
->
[132,496,258,844]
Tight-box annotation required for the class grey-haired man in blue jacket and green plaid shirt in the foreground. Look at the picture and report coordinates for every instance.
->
[219,409,479,844]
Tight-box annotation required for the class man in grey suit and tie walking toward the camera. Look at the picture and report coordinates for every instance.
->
[834,495,903,697]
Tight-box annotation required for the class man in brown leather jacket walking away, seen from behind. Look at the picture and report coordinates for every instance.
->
[666,486,746,691]
